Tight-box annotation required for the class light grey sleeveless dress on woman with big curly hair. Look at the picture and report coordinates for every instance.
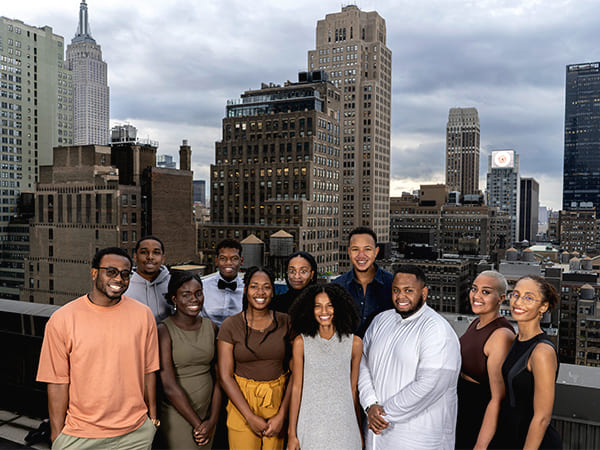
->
[297,333,362,450]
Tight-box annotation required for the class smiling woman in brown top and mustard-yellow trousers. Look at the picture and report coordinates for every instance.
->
[217,267,290,450]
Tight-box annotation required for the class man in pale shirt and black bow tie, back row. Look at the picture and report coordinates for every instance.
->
[200,239,244,327]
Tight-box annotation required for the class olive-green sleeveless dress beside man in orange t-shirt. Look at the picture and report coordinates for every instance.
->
[160,317,215,449]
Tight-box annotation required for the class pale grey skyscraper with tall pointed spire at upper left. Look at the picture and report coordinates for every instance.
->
[67,0,110,145]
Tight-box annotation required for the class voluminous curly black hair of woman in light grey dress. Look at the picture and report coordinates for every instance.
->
[290,283,360,340]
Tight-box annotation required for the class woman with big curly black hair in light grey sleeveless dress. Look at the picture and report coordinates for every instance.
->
[288,284,362,450]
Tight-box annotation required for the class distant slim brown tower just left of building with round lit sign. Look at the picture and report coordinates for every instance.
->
[446,108,480,195]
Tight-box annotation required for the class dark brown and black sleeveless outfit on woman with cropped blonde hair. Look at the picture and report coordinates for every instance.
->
[456,317,514,449]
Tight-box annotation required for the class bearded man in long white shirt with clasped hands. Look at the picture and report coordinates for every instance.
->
[358,265,461,450]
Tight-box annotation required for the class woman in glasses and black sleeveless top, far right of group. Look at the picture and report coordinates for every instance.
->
[492,275,561,449]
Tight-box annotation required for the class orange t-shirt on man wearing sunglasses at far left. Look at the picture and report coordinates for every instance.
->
[37,296,159,438]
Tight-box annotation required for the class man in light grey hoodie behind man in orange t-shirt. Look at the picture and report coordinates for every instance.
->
[125,236,171,323]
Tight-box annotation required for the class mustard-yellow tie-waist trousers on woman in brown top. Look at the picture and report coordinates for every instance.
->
[227,374,286,450]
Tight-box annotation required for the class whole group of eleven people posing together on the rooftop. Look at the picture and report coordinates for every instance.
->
[37,227,560,450]
